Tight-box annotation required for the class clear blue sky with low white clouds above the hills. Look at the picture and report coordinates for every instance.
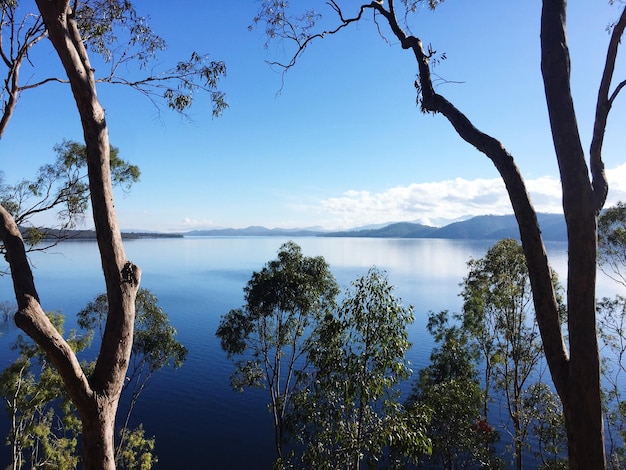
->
[0,0,626,231]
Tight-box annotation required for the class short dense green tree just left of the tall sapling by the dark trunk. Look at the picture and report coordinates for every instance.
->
[408,311,501,468]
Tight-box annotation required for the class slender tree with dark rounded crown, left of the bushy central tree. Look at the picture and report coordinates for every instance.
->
[216,242,338,461]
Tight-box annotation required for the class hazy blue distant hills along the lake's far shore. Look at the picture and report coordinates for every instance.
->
[184,214,567,241]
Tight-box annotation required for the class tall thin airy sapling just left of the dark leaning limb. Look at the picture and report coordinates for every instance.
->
[462,239,543,469]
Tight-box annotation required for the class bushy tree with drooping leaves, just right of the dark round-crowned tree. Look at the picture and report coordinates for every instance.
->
[291,269,430,468]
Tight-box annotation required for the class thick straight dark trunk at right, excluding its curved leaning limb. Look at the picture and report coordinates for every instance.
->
[541,0,606,469]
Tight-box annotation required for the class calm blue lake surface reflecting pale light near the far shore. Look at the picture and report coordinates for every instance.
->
[0,237,617,469]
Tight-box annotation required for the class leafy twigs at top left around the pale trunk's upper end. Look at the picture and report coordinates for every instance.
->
[0,0,226,139]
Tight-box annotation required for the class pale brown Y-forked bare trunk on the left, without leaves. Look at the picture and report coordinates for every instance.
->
[0,0,141,470]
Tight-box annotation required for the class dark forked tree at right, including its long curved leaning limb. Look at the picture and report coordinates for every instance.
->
[368,0,608,469]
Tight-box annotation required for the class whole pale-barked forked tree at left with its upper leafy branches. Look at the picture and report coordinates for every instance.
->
[0,0,224,470]
